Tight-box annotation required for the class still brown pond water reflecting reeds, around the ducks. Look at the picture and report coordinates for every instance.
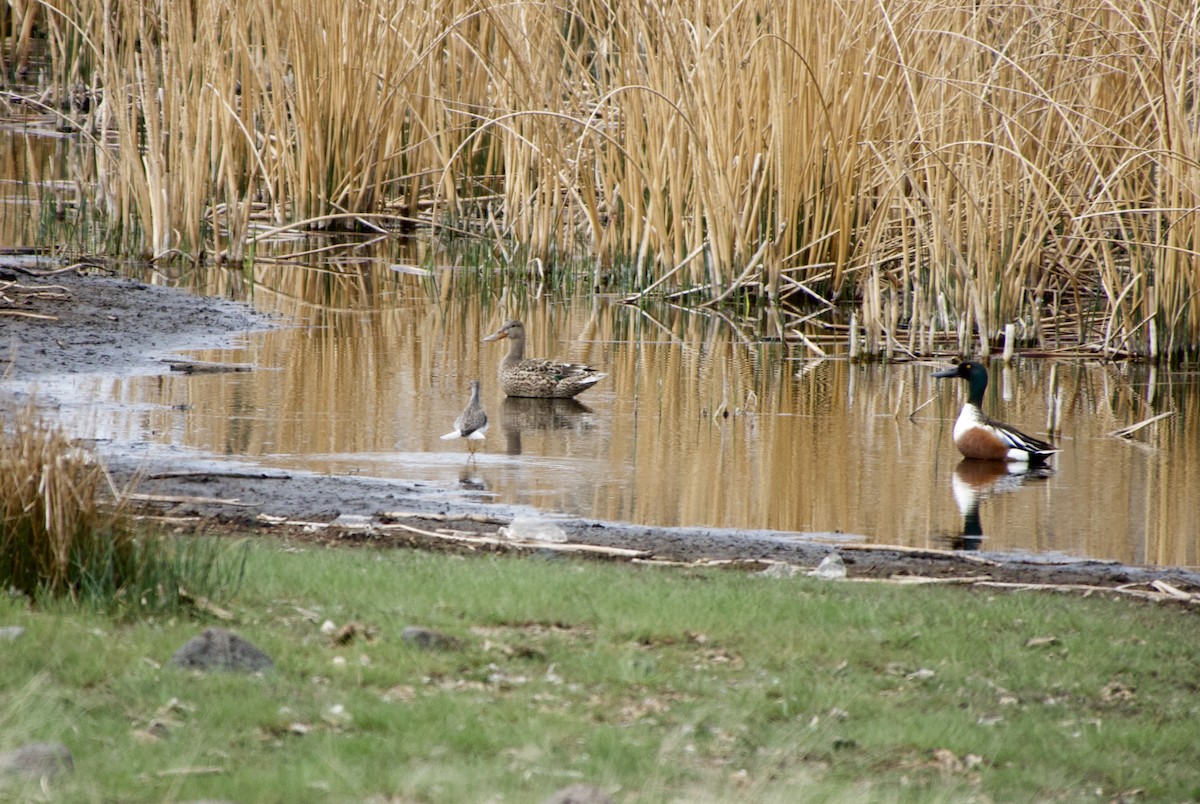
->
[18,261,1200,565]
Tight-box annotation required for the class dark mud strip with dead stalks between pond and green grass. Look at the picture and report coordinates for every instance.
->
[119,461,1200,590]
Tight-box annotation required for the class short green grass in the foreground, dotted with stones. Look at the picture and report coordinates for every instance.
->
[0,544,1200,802]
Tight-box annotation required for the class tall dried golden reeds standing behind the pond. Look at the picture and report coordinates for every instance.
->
[32,0,1200,358]
